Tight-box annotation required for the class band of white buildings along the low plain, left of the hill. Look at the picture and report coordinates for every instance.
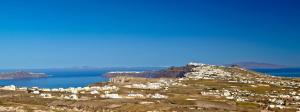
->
[0,83,168,100]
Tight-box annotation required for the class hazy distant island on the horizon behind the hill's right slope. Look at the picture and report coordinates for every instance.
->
[227,62,288,69]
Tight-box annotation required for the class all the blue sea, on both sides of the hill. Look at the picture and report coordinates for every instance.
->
[0,67,300,88]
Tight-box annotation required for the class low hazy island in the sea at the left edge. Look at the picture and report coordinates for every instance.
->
[0,71,48,80]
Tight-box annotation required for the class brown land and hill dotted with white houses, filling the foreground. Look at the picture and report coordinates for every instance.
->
[0,63,300,112]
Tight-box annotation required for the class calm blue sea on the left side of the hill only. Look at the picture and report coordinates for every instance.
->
[0,68,162,88]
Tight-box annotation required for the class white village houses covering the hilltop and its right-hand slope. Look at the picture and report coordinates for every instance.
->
[185,63,300,109]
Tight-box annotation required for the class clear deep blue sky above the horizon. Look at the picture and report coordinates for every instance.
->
[0,0,300,68]
